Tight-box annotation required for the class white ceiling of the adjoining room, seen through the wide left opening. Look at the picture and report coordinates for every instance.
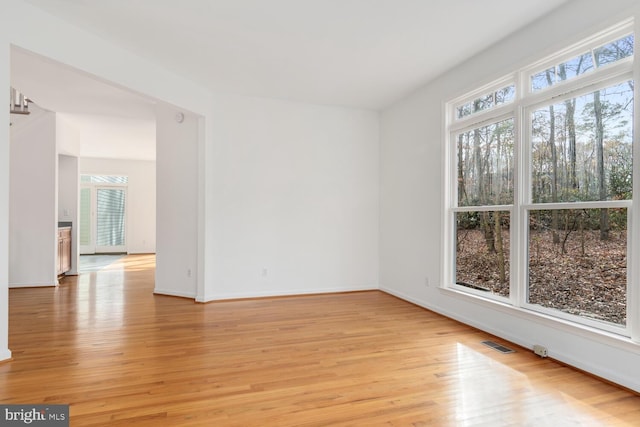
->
[11,47,156,160]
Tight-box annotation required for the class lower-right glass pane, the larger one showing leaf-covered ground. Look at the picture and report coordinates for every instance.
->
[528,208,627,325]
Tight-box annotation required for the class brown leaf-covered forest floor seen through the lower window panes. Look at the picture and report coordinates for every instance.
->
[456,230,627,325]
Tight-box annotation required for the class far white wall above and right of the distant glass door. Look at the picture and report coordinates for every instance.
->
[79,157,156,254]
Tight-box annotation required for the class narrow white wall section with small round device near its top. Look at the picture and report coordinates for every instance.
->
[154,104,198,298]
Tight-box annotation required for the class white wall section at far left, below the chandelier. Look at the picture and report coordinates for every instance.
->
[9,105,58,287]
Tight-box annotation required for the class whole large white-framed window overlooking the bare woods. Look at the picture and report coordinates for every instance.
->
[444,23,640,336]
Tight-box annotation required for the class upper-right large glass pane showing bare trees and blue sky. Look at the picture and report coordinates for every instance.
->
[531,81,633,203]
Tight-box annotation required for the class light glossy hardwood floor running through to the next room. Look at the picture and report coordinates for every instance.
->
[0,255,640,427]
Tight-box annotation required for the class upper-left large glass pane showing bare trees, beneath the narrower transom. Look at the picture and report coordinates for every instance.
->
[455,119,514,206]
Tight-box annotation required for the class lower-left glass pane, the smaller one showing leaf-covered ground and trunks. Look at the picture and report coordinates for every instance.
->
[455,211,511,297]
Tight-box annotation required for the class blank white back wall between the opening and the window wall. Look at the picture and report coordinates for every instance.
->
[202,96,379,300]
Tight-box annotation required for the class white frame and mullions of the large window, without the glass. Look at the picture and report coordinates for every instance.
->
[440,19,640,342]
